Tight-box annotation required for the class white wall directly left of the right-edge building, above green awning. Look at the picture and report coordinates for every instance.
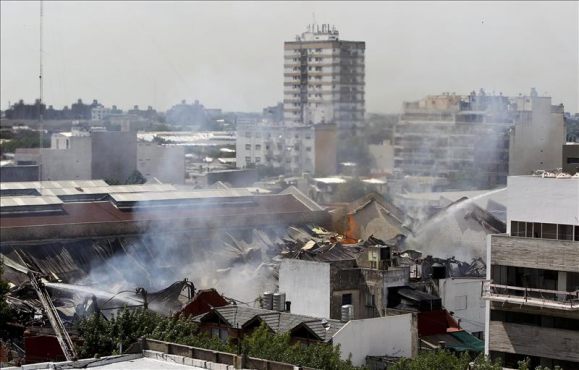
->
[439,278,485,333]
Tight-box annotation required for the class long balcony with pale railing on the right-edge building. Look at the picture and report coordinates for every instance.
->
[483,281,579,312]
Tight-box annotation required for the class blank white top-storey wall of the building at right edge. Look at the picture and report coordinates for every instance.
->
[507,176,579,227]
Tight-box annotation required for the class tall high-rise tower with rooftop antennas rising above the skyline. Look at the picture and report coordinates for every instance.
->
[283,24,366,128]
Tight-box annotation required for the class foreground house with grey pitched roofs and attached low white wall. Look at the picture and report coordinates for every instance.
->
[194,305,417,366]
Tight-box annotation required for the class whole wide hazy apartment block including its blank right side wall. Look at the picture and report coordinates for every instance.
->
[393,89,564,188]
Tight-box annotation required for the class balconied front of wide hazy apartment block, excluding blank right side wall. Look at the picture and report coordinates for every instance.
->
[394,91,510,188]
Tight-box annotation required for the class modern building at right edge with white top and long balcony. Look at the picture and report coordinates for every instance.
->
[483,176,579,369]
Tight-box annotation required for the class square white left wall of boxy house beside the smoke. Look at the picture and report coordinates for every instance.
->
[279,259,330,318]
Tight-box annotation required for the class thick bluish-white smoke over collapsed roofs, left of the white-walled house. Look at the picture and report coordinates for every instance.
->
[77,223,285,302]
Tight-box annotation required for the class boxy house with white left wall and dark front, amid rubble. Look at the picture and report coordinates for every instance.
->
[279,241,410,319]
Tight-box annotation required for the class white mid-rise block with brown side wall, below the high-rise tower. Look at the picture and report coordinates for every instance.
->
[236,124,337,176]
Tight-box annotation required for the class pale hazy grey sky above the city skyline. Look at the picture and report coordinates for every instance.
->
[0,1,579,112]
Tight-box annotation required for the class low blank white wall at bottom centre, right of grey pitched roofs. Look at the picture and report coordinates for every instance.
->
[332,314,418,366]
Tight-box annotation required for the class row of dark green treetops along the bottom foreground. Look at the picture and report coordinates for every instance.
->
[77,309,355,370]
